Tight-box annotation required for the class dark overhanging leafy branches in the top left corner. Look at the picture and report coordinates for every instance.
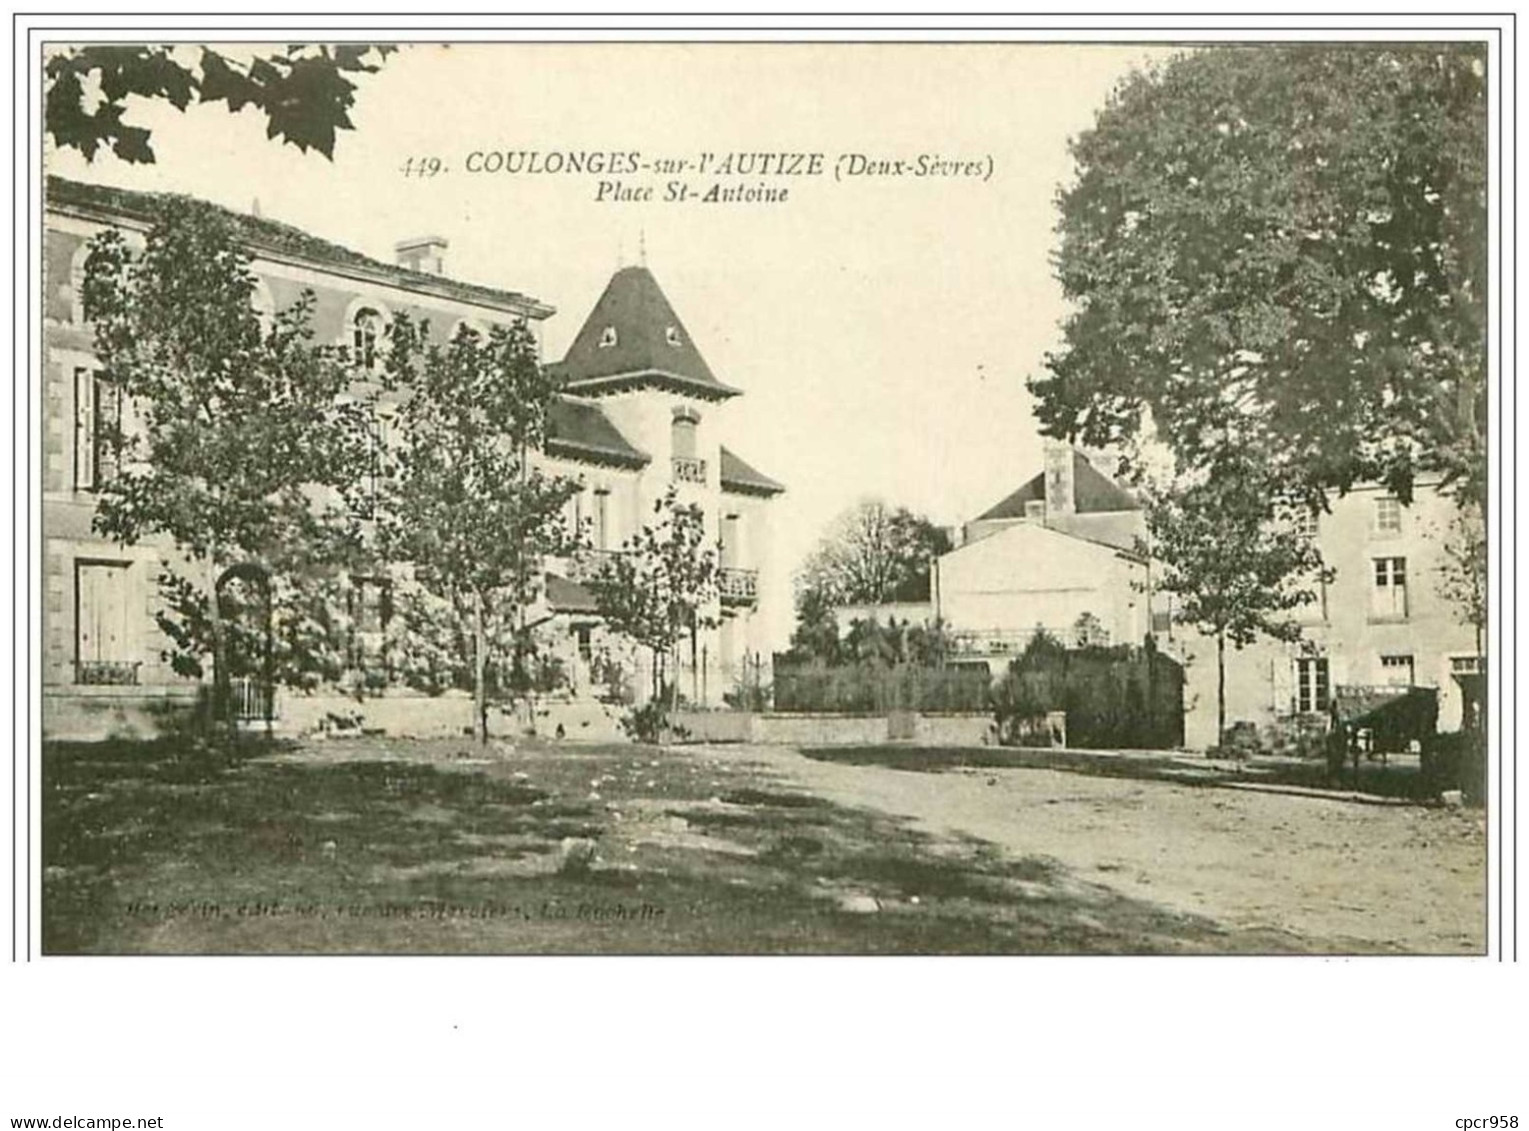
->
[43,44,396,164]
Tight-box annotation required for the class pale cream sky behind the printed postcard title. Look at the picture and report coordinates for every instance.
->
[47,43,1162,636]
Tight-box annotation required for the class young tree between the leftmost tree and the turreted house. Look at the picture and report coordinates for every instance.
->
[378,315,579,743]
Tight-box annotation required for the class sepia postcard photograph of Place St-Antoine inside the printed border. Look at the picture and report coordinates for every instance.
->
[29,32,1492,965]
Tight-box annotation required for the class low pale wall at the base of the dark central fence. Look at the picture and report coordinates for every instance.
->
[671,711,992,746]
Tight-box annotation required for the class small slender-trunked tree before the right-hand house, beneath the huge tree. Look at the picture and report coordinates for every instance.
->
[1144,460,1332,741]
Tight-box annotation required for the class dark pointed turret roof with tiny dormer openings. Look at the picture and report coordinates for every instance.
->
[557,267,739,400]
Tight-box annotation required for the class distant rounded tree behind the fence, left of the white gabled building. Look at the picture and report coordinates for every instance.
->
[798,500,951,605]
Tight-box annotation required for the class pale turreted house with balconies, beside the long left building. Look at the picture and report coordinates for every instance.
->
[543,266,784,706]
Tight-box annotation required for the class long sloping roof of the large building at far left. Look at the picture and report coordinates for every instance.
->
[44,177,553,318]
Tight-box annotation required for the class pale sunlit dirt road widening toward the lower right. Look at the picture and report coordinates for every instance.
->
[706,746,1486,954]
